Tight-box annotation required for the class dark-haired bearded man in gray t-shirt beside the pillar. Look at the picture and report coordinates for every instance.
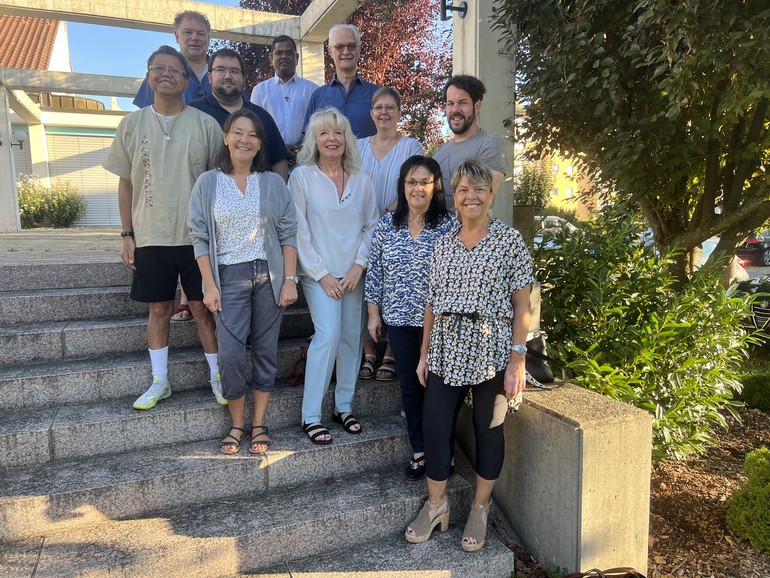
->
[433,75,508,208]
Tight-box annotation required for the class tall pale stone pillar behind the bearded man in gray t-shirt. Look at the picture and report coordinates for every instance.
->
[452,0,515,225]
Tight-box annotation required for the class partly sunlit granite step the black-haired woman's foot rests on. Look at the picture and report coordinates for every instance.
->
[4,466,486,578]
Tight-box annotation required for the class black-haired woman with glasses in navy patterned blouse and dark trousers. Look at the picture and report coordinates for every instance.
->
[364,155,457,480]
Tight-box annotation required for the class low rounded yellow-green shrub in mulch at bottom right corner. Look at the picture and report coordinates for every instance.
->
[727,447,770,552]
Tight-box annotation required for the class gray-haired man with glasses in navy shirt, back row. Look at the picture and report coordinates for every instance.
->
[305,24,379,138]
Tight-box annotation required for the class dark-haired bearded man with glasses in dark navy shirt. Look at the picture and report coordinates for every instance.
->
[189,48,291,181]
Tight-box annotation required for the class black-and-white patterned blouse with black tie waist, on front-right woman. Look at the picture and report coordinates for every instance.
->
[428,219,535,386]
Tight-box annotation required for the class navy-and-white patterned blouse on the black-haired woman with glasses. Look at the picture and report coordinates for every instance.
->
[364,213,457,327]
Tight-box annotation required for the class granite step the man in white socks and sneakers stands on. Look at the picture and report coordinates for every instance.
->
[0,382,401,468]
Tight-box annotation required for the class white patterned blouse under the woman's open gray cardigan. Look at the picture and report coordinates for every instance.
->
[214,171,267,265]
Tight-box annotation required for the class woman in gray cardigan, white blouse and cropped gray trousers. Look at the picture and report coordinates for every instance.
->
[187,109,298,454]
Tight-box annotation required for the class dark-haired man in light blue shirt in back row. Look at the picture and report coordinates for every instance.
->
[251,35,318,165]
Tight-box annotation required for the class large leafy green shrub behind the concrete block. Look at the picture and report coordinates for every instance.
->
[536,210,754,458]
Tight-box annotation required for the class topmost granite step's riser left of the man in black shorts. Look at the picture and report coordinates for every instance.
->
[0,254,131,291]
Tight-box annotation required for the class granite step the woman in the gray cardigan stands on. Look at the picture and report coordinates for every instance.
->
[0,414,411,540]
